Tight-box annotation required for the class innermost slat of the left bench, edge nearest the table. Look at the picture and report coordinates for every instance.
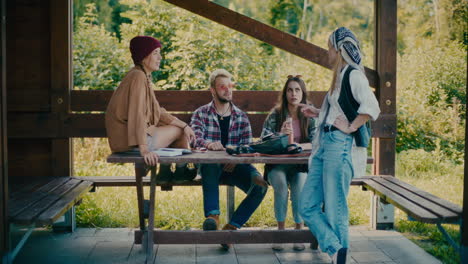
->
[35,181,93,226]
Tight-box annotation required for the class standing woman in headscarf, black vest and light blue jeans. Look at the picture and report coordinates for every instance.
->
[300,27,380,264]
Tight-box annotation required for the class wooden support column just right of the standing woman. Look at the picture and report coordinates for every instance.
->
[371,0,397,229]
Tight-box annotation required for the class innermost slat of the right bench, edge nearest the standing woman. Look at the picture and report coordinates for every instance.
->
[364,179,439,223]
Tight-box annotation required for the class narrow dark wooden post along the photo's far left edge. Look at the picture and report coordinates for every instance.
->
[0,0,10,264]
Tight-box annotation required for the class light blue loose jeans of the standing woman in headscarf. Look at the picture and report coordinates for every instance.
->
[300,130,353,255]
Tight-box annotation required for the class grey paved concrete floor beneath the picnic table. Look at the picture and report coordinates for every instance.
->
[14,226,441,264]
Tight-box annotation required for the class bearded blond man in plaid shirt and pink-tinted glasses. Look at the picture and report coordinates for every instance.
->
[190,69,267,249]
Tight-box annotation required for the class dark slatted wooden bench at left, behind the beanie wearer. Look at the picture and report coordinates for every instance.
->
[8,177,93,260]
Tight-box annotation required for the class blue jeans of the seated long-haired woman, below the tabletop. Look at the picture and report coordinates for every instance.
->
[268,164,307,224]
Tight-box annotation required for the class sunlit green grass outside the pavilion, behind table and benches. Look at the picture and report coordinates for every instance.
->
[74,139,463,263]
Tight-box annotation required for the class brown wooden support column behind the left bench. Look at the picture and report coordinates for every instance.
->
[50,0,75,231]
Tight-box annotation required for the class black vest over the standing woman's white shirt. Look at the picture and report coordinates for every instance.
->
[338,66,370,147]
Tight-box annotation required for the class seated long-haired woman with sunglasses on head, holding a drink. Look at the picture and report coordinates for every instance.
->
[262,75,315,251]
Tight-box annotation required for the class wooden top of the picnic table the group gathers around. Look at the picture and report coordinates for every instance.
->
[107,151,310,164]
